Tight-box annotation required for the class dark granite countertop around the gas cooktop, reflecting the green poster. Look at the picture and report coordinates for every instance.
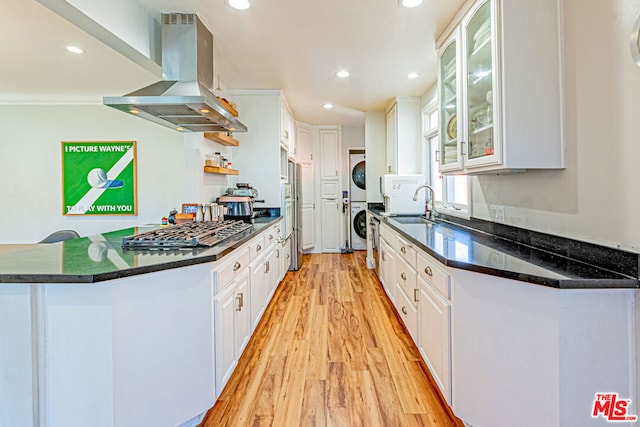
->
[0,216,281,283]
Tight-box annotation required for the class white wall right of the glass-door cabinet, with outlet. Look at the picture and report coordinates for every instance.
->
[472,0,640,252]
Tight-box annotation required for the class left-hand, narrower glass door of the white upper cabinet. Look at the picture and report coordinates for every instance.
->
[438,31,464,172]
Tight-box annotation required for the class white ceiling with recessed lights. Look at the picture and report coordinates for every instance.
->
[0,0,464,125]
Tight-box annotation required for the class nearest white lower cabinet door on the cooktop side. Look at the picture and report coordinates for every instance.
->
[213,285,237,395]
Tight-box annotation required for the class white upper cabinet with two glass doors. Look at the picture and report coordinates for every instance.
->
[438,0,564,174]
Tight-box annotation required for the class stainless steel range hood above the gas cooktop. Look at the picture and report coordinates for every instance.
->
[103,13,247,132]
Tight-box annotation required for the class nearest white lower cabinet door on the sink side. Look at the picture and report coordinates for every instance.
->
[418,279,451,404]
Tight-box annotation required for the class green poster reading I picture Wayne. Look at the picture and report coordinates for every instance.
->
[62,141,138,215]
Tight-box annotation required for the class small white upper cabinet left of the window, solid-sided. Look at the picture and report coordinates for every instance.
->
[386,96,421,173]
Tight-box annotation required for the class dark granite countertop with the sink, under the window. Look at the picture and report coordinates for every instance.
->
[369,209,640,289]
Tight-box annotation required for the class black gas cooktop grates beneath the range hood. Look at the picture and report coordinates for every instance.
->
[122,220,253,249]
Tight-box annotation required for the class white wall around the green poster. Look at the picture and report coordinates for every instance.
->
[0,105,226,243]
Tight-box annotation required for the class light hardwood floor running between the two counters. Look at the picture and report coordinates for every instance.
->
[201,251,462,427]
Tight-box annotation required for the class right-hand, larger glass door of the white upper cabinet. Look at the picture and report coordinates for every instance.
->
[462,0,501,167]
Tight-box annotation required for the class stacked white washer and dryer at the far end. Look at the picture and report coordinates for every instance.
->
[349,153,367,250]
